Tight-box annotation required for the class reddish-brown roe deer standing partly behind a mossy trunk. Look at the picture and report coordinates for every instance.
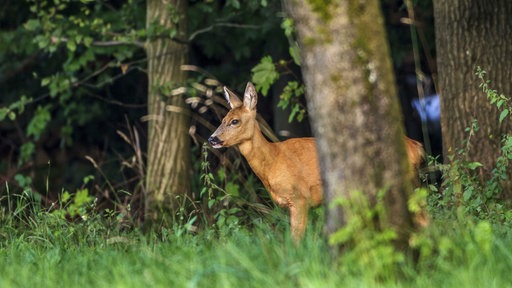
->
[208,82,423,242]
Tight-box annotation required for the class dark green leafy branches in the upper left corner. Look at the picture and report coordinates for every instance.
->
[0,0,145,169]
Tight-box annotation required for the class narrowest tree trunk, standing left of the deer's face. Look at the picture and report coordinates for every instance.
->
[145,0,191,221]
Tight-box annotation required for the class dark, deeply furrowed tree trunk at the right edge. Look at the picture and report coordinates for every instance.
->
[434,0,512,196]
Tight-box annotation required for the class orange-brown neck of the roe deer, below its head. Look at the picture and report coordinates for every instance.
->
[238,122,276,184]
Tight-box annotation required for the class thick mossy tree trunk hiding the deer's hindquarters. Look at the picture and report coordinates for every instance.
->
[285,0,413,248]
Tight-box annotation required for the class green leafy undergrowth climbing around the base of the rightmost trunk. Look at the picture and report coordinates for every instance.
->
[433,67,512,222]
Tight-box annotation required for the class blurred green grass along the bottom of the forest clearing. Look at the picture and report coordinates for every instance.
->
[0,206,512,287]
